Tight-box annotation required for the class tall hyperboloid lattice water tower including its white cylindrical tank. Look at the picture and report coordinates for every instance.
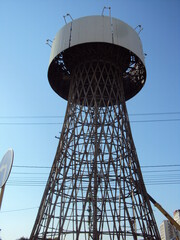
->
[31,16,160,240]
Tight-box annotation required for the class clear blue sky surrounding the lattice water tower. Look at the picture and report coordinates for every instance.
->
[0,0,180,240]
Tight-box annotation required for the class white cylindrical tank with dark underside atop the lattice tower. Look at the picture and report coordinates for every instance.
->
[48,16,146,100]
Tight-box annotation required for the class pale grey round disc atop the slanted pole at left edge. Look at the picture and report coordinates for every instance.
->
[0,149,14,188]
